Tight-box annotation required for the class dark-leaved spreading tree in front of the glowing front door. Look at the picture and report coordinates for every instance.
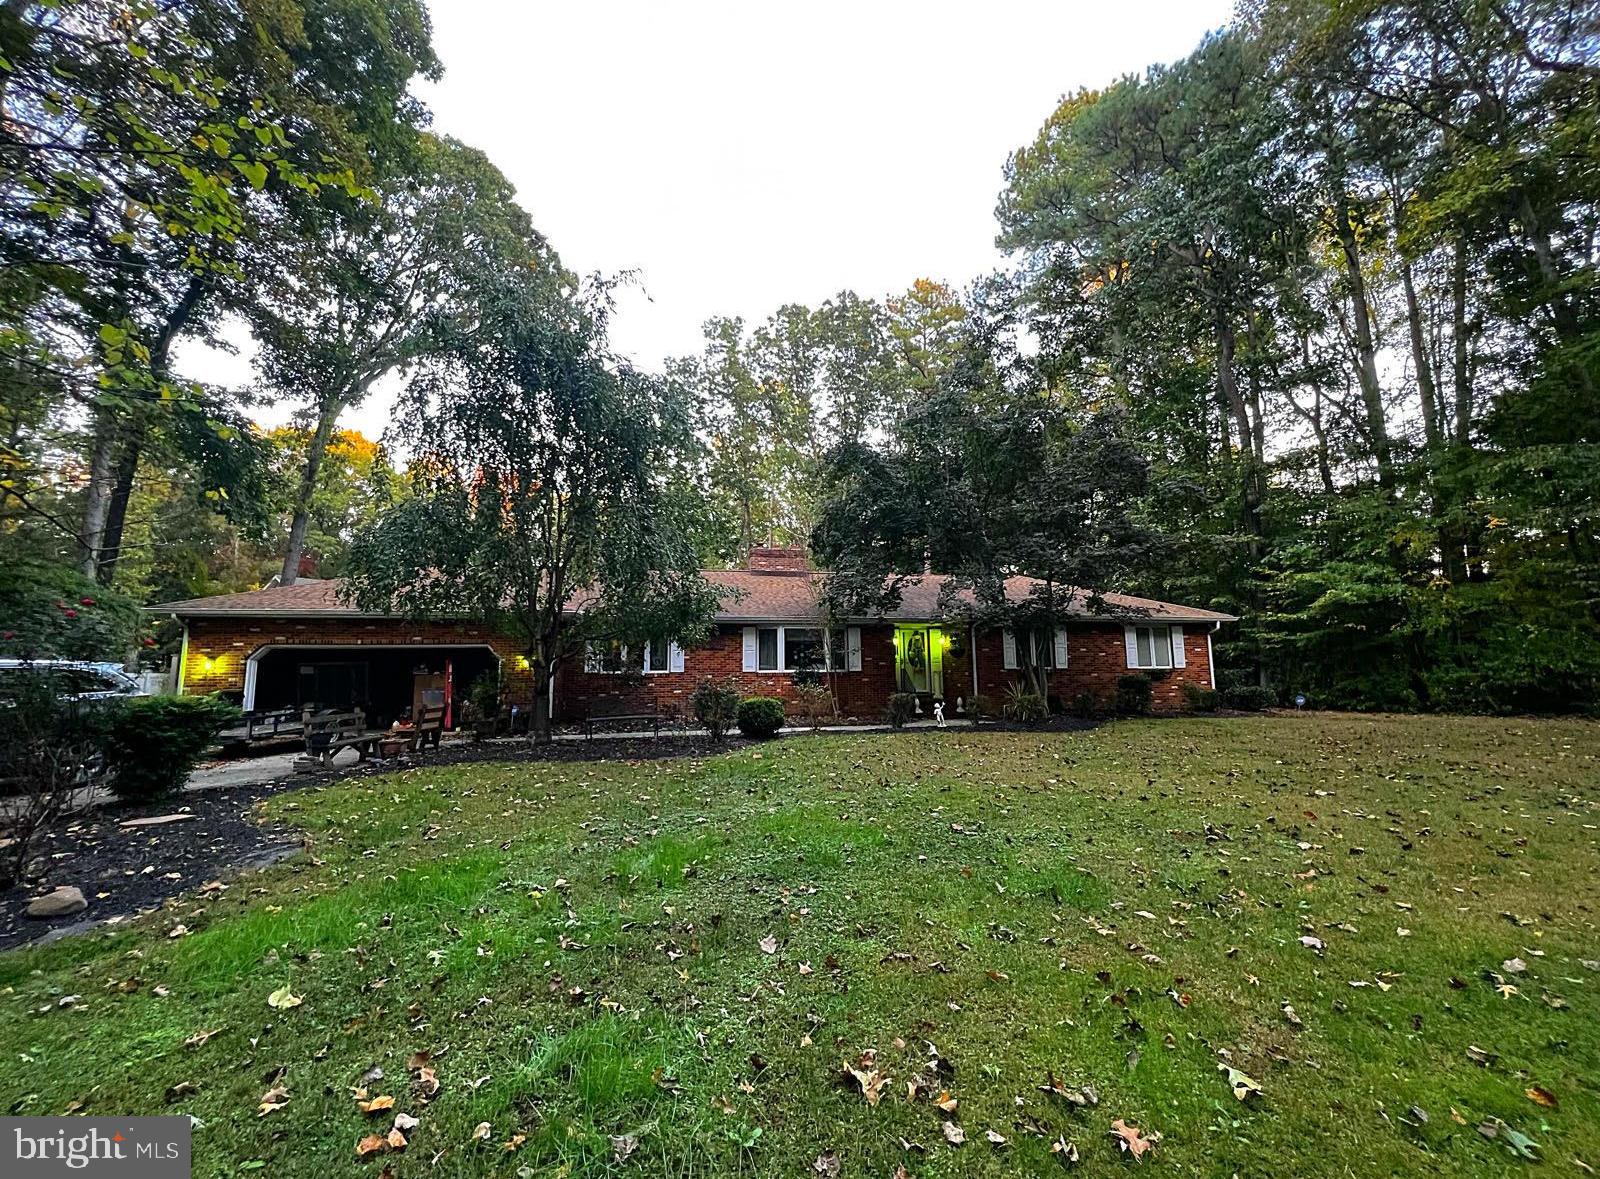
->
[813,284,1162,697]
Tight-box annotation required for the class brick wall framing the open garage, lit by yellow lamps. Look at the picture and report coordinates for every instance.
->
[184,617,533,704]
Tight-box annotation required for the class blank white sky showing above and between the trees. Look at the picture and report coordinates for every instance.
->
[179,0,1232,437]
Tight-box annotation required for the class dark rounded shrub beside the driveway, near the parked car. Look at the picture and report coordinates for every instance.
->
[106,696,240,801]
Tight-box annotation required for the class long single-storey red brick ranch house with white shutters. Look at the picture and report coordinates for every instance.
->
[150,549,1234,723]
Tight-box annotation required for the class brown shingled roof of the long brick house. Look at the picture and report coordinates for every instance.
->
[149,570,1234,622]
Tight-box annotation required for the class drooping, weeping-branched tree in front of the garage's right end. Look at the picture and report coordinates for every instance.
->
[344,269,717,741]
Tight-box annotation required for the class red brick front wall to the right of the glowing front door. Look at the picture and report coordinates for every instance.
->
[966,622,1213,712]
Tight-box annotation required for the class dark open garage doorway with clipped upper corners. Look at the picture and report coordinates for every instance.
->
[245,646,499,728]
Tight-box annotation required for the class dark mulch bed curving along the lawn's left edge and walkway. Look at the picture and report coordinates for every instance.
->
[0,736,744,950]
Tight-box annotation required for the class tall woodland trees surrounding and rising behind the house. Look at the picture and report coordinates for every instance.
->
[0,0,1600,710]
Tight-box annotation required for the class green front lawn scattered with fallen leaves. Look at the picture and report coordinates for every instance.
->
[0,717,1600,1176]
